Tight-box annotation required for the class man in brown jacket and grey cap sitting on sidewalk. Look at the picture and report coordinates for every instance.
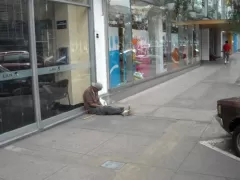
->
[83,83,130,116]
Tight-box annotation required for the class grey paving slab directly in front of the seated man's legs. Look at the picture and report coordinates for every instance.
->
[67,116,174,136]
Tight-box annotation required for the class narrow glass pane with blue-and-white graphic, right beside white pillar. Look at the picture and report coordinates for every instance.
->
[108,0,133,88]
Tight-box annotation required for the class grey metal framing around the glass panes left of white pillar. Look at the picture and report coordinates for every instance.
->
[0,0,96,146]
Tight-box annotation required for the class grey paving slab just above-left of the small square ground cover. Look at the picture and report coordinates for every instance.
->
[21,125,116,154]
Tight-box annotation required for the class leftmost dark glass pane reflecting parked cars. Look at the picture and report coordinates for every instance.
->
[0,0,35,134]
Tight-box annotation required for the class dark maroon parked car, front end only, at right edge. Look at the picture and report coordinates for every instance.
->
[216,97,240,157]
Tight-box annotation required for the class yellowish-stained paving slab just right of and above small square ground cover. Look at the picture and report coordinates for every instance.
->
[89,133,196,170]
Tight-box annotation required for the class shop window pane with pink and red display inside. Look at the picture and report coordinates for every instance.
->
[131,0,167,80]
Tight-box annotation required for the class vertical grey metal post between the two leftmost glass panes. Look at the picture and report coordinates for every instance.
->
[28,0,42,129]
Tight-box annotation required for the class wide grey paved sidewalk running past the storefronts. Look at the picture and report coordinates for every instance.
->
[0,54,240,180]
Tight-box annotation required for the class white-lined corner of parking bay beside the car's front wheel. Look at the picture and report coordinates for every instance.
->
[199,138,240,161]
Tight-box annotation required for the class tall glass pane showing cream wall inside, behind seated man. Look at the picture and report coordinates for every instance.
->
[35,0,90,119]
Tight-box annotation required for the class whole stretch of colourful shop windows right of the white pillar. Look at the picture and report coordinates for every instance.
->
[108,0,200,88]
